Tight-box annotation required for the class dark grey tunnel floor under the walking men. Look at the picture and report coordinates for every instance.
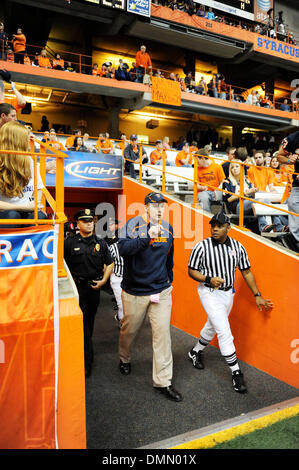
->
[86,292,299,449]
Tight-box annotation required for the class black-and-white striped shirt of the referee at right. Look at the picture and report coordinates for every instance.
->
[188,237,250,289]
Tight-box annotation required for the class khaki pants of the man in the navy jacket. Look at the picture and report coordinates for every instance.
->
[119,287,173,387]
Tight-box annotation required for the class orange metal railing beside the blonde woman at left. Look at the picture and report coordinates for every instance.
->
[0,139,67,277]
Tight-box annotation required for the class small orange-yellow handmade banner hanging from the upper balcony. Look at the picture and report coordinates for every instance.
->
[152,77,182,106]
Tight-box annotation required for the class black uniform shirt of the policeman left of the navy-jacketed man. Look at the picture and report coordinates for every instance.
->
[64,233,113,280]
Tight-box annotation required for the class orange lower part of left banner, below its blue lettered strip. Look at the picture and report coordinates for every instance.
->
[0,255,55,449]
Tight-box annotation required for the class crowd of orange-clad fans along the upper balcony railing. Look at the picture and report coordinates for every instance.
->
[0,24,291,111]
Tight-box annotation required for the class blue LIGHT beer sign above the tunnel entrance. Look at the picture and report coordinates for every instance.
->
[46,152,123,189]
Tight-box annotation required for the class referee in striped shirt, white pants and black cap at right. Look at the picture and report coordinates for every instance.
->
[188,212,273,393]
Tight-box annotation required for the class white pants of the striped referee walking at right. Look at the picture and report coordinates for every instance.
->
[197,284,235,356]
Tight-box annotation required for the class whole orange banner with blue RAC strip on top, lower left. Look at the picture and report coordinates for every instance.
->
[0,227,59,449]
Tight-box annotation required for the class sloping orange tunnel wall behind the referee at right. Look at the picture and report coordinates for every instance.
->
[119,178,299,388]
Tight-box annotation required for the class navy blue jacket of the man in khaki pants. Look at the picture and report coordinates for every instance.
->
[118,216,174,295]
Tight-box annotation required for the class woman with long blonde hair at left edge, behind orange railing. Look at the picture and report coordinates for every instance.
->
[0,121,47,228]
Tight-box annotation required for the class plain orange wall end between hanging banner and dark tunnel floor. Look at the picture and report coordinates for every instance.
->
[57,298,86,449]
